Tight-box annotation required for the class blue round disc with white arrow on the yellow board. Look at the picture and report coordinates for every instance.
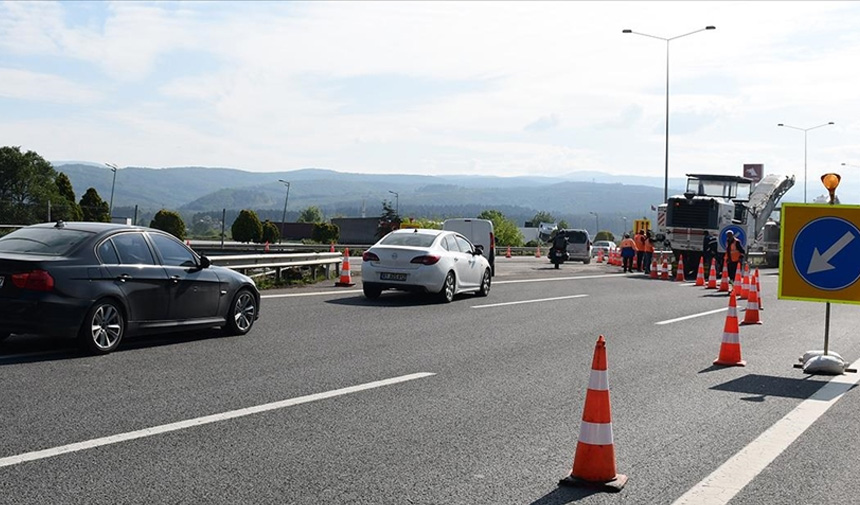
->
[792,217,860,291]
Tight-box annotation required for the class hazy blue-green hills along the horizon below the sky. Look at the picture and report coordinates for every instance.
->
[55,162,683,228]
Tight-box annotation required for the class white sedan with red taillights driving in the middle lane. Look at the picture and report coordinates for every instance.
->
[361,228,491,302]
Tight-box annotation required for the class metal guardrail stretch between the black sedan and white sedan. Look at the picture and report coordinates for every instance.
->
[208,252,343,278]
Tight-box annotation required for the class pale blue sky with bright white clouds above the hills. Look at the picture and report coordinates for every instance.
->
[0,1,860,197]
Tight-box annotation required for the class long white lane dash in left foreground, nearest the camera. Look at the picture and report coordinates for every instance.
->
[0,373,436,468]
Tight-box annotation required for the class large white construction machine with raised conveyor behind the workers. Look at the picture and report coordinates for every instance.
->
[656,174,794,278]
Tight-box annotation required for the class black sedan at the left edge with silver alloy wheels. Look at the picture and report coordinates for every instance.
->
[0,221,260,354]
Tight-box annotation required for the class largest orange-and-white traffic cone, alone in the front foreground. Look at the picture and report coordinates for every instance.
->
[558,335,627,492]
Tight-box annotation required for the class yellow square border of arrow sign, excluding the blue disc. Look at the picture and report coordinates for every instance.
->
[778,203,860,304]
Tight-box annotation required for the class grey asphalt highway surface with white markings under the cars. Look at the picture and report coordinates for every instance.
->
[0,257,860,505]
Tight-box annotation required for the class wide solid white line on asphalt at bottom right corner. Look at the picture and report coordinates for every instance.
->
[673,360,860,505]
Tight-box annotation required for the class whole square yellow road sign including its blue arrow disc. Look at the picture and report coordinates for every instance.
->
[779,203,860,304]
